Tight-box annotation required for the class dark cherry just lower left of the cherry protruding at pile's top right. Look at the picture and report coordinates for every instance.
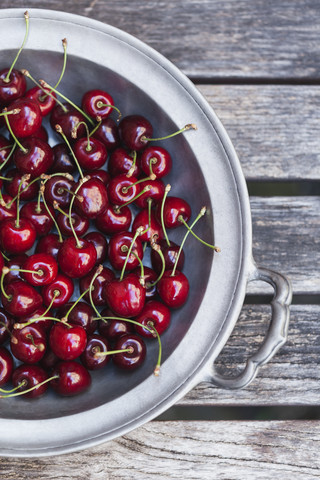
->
[50,103,86,140]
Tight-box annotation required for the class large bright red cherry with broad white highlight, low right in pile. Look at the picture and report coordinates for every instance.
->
[105,273,146,318]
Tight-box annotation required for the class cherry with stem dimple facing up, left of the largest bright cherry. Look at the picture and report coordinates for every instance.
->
[40,273,74,308]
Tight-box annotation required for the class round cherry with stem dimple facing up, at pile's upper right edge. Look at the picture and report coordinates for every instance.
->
[140,145,172,178]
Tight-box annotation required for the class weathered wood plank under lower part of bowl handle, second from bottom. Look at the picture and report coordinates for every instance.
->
[179,305,320,406]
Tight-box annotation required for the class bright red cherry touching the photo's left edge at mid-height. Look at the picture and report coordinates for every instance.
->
[0,218,37,254]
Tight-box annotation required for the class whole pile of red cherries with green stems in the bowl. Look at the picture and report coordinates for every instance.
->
[0,13,216,398]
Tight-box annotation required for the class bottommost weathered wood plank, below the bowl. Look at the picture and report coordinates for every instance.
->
[0,421,320,480]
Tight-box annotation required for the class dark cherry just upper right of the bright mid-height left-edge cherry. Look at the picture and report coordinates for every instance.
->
[20,201,55,237]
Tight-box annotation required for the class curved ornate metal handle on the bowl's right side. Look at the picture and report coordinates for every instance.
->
[209,267,292,389]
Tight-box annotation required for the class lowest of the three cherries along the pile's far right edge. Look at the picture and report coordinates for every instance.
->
[157,270,189,308]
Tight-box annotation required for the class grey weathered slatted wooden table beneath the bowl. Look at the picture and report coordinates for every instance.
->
[0,0,320,480]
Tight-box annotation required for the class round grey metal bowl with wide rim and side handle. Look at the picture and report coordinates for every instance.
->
[0,9,291,457]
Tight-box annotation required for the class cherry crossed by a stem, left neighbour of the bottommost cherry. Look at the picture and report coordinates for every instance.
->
[12,364,48,398]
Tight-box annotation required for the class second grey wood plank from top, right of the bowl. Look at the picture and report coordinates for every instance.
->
[198,85,320,180]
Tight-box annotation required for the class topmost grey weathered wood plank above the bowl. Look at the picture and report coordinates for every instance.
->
[1,0,320,79]
